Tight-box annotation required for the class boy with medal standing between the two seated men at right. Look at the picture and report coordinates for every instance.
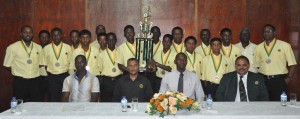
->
[202,38,234,99]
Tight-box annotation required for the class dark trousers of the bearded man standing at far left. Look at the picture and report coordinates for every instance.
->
[13,76,42,102]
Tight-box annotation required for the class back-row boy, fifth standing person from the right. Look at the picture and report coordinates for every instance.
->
[195,29,211,57]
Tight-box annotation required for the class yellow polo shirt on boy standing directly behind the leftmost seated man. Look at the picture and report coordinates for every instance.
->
[69,45,100,76]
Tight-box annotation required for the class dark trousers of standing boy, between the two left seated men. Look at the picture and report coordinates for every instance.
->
[97,76,120,102]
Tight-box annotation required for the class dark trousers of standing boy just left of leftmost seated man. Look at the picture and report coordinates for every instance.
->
[47,72,69,102]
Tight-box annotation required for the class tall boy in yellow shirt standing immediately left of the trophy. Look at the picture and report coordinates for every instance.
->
[116,25,136,72]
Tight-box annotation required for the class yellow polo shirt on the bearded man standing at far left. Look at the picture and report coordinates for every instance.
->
[3,41,43,78]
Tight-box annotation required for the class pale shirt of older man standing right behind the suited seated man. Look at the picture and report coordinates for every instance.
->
[235,42,258,73]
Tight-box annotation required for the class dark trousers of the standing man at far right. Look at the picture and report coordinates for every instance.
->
[261,74,288,101]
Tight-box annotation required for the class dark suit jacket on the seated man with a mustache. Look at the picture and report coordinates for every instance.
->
[216,71,269,101]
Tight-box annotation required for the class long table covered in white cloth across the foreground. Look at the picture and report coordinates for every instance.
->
[0,102,300,119]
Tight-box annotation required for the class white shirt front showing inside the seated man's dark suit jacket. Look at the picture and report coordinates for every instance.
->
[235,73,249,102]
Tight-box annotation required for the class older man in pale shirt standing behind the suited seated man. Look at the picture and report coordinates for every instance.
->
[235,28,257,73]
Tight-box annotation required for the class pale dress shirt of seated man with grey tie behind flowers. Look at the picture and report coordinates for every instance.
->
[159,70,204,103]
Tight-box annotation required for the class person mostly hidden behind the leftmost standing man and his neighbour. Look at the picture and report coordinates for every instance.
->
[39,30,50,99]
